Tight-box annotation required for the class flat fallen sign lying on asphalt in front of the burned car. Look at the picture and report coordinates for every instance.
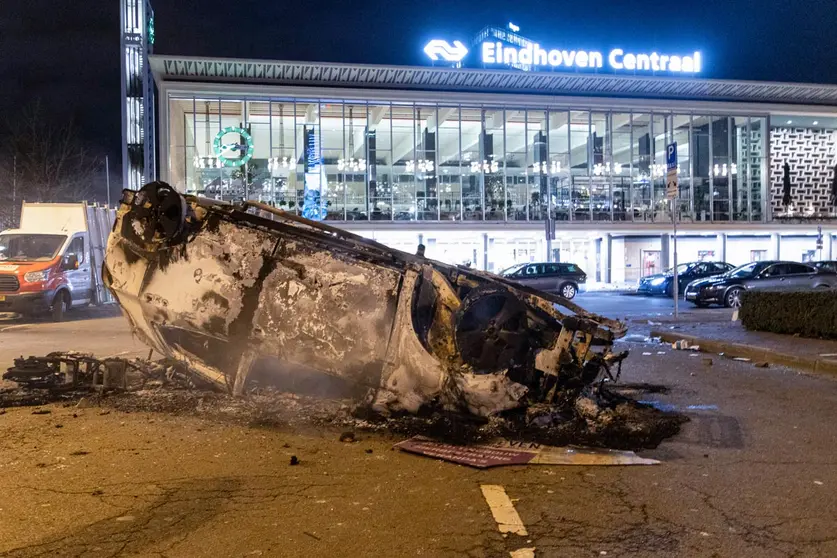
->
[395,436,660,469]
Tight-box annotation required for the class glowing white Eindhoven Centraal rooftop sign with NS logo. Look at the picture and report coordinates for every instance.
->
[424,23,703,75]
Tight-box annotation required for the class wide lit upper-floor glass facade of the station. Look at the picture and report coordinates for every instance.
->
[167,97,768,223]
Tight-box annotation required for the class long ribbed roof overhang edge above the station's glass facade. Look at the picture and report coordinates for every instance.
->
[151,55,837,106]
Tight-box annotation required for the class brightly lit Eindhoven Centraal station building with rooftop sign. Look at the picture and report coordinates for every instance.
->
[127,20,837,283]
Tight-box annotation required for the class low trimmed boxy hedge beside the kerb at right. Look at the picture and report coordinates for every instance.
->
[739,290,837,339]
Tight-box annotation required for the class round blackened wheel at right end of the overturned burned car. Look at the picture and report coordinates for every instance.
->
[455,287,528,374]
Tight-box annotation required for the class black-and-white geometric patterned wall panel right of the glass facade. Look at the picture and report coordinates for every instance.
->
[770,128,837,213]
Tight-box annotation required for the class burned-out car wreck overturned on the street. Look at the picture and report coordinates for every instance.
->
[104,182,626,416]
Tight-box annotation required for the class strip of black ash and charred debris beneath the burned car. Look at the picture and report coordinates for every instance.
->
[0,360,688,450]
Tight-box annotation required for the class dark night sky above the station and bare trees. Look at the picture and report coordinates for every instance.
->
[0,0,837,177]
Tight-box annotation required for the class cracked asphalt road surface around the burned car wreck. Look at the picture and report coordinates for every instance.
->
[0,306,837,558]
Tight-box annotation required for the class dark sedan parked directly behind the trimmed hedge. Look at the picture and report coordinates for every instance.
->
[685,261,837,308]
